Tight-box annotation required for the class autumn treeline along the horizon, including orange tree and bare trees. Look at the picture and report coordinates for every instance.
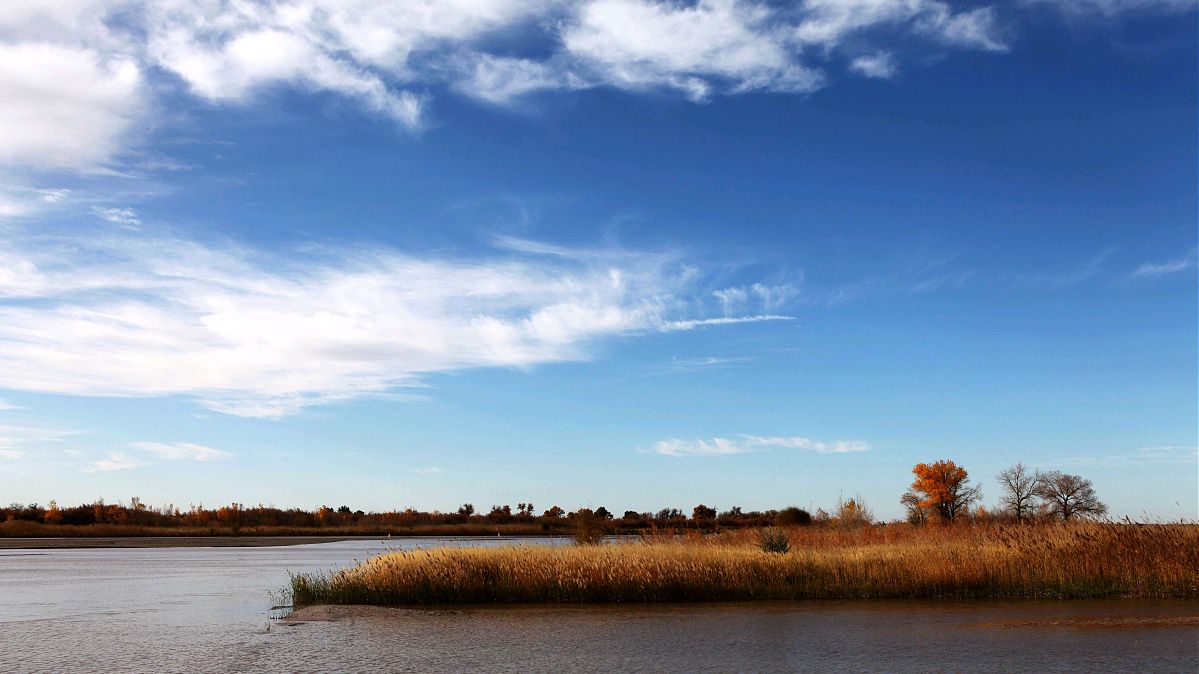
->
[0,459,1108,537]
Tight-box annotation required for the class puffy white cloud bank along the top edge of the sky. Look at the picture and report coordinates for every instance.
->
[0,0,1007,171]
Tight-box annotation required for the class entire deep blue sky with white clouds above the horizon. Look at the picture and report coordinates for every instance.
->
[0,0,1199,518]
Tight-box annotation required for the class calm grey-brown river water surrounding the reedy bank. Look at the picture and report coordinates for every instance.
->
[0,540,1199,673]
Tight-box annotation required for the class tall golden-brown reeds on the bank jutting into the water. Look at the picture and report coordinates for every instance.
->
[291,523,1199,606]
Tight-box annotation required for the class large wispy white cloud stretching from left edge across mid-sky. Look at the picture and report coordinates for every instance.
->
[0,226,789,417]
